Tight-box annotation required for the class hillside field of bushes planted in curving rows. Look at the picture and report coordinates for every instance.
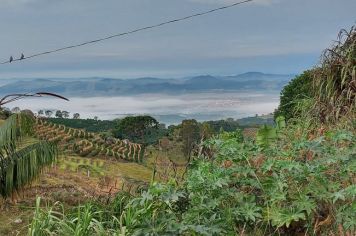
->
[36,119,145,162]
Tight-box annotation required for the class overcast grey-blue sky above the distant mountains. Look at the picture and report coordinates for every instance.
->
[0,0,356,78]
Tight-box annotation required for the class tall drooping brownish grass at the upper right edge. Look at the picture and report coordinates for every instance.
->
[314,25,356,123]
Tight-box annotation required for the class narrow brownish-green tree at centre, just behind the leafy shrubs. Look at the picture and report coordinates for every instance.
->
[180,119,200,158]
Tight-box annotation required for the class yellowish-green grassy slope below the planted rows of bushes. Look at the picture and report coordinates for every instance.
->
[0,153,152,235]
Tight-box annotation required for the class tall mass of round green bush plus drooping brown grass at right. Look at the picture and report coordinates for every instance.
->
[275,26,356,125]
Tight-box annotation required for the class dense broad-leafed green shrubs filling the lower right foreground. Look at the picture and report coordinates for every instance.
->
[32,122,356,235]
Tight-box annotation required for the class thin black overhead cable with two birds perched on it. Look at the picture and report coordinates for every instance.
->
[0,0,254,65]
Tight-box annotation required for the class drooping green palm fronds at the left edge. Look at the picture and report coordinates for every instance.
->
[0,113,57,198]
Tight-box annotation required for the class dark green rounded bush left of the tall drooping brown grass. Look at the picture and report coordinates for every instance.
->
[275,71,313,120]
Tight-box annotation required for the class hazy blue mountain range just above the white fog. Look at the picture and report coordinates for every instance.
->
[0,72,293,97]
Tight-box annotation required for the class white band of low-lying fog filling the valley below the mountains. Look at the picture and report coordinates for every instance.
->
[5,92,279,124]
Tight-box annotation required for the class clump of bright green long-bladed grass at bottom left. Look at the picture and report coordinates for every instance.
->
[28,193,130,236]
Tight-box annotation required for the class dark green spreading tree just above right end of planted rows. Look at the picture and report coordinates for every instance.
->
[113,116,159,143]
